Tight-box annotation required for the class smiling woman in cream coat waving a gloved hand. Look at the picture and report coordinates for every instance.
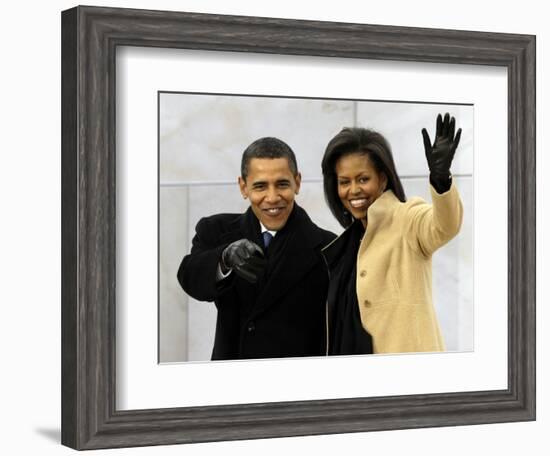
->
[322,114,462,355]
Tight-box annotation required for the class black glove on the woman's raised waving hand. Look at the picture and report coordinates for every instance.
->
[422,113,462,193]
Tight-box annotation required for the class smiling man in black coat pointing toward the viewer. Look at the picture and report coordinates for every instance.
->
[178,138,335,360]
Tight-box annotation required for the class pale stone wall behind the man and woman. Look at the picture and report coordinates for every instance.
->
[159,93,474,362]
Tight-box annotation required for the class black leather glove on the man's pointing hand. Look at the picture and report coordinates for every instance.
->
[221,239,266,283]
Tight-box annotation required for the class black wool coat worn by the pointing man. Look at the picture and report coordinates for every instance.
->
[178,204,335,360]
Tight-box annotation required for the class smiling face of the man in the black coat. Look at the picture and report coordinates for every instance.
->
[239,158,301,231]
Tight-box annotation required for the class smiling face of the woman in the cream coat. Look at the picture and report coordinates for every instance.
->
[335,152,387,226]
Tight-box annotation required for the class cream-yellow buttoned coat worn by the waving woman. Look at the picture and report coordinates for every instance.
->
[357,184,463,353]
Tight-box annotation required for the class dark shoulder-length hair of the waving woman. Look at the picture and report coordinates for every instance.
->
[321,127,406,228]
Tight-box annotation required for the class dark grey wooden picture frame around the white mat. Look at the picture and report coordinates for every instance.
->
[62,7,536,449]
